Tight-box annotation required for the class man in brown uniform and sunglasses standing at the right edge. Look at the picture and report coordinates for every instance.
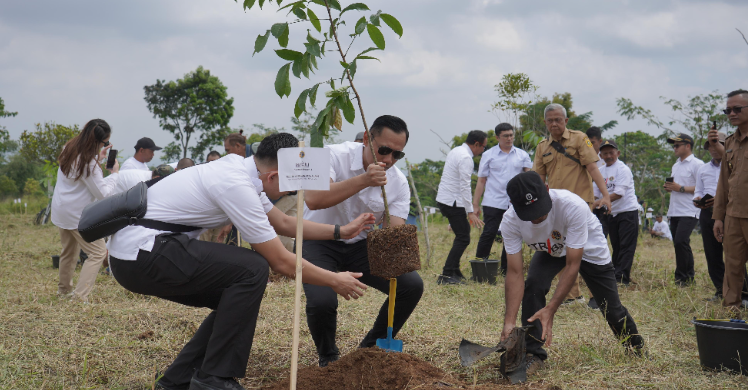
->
[708,90,748,308]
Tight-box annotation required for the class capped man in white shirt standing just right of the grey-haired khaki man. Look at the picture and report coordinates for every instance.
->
[594,140,640,286]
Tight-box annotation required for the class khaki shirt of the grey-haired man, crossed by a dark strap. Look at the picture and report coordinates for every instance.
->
[534,129,599,204]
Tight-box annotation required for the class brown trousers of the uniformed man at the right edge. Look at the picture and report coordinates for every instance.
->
[724,215,748,307]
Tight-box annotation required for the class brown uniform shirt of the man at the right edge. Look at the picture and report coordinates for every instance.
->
[713,131,747,221]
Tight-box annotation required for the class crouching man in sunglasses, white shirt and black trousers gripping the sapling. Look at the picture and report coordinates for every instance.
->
[302,116,424,367]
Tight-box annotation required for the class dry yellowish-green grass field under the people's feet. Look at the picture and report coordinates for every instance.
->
[0,214,748,390]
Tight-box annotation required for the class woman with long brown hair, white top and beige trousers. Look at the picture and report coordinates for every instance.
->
[52,119,120,302]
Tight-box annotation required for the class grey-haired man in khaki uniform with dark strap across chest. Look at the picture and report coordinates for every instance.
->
[534,103,612,303]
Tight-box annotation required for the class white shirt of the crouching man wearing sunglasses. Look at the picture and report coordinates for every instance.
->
[304,142,411,244]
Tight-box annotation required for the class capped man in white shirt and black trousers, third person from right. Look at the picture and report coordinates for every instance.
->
[664,134,703,287]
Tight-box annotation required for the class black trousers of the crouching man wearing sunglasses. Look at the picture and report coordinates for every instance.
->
[302,240,424,360]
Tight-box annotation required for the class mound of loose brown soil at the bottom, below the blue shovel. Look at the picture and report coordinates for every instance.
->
[263,348,549,390]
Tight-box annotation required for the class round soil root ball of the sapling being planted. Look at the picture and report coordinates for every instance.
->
[367,225,422,279]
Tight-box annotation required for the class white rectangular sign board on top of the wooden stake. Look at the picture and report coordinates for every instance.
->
[278,148,331,192]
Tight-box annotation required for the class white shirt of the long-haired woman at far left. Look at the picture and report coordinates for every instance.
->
[52,159,119,230]
